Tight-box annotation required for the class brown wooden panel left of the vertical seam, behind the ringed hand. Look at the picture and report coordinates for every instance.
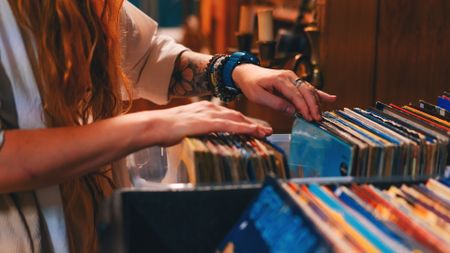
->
[320,0,377,109]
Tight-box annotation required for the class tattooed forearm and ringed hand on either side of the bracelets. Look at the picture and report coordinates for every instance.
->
[169,51,336,120]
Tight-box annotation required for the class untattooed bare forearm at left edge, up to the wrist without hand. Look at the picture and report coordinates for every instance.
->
[0,111,157,192]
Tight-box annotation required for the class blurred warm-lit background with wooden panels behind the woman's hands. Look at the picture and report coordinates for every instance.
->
[130,0,450,133]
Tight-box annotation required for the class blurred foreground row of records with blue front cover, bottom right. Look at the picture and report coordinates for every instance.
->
[218,179,450,252]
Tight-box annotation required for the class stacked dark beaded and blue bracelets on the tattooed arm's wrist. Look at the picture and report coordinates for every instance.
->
[206,52,259,102]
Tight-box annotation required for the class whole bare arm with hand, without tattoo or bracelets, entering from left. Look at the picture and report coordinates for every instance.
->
[0,102,271,192]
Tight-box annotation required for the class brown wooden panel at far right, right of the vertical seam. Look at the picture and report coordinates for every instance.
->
[376,0,450,104]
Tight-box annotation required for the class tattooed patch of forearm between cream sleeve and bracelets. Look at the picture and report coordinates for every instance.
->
[169,51,211,98]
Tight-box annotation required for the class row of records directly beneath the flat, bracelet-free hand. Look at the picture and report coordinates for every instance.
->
[178,133,289,184]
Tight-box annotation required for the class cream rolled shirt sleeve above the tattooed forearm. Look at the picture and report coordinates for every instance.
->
[121,1,187,104]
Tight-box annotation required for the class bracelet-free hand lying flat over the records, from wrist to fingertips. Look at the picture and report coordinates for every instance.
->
[147,101,272,146]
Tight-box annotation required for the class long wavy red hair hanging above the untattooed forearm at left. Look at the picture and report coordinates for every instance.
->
[9,0,131,127]
